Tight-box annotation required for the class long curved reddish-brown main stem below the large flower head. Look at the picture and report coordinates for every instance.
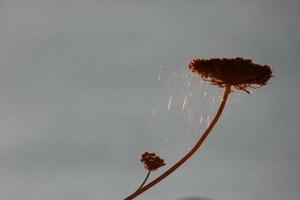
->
[125,85,231,200]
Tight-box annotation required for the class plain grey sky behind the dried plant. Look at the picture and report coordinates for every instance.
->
[0,0,300,200]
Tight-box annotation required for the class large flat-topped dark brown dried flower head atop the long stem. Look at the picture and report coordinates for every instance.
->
[189,58,272,93]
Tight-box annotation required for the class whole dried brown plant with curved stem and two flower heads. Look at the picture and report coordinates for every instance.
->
[125,58,272,200]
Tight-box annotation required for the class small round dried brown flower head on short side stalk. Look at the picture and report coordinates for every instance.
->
[141,152,166,171]
